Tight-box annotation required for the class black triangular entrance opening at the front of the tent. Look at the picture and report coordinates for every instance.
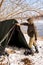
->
[9,26,28,48]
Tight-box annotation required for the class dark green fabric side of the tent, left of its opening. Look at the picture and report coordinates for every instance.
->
[0,19,17,48]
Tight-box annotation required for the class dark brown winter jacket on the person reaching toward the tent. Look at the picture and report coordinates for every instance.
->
[21,23,37,40]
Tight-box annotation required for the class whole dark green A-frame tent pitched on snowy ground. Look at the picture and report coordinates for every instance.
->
[0,19,28,51]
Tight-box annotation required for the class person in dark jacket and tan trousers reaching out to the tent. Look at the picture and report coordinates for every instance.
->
[17,18,39,55]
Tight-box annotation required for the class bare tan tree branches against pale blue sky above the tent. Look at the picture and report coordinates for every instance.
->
[0,0,43,20]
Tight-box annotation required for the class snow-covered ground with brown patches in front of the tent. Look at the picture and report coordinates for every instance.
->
[0,35,43,65]
